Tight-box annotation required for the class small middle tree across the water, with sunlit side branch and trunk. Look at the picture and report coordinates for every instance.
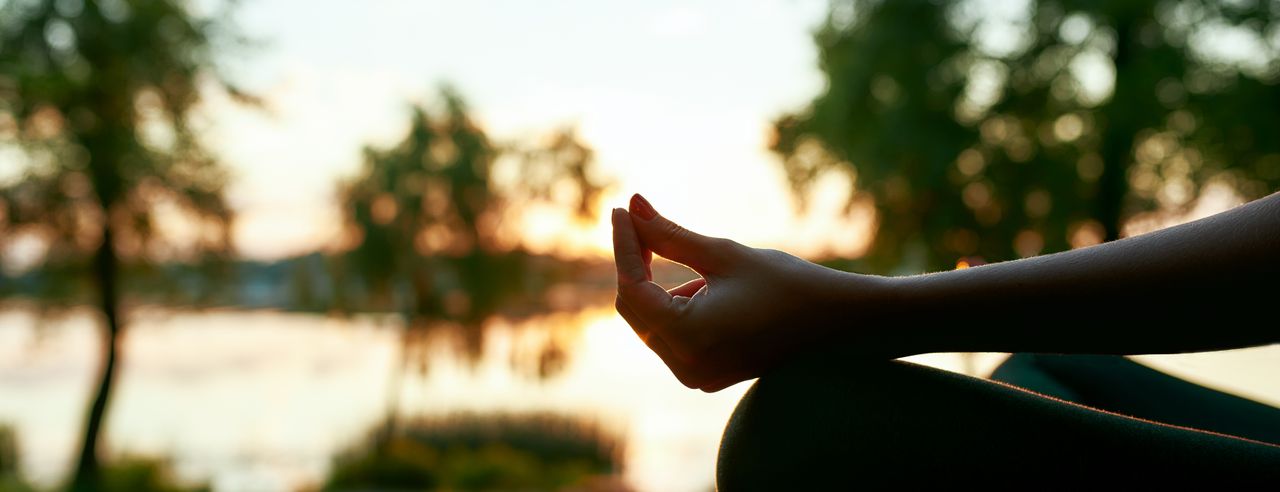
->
[339,87,604,452]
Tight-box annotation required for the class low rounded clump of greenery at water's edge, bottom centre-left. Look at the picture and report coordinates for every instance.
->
[324,414,622,491]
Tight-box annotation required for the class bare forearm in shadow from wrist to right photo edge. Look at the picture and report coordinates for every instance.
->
[860,193,1280,355]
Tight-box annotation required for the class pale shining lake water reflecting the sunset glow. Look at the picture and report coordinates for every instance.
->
[0,306,1280,491]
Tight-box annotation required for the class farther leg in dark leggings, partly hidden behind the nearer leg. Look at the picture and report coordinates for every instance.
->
[991,354,1280,445]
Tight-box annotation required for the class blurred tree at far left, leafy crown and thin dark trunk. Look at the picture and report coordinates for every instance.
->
[0,0,243,489]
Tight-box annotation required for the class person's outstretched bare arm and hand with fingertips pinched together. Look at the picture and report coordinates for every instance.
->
[613,189,1280,391]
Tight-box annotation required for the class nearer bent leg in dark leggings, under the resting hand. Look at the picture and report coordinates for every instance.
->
[717,343,1280,491]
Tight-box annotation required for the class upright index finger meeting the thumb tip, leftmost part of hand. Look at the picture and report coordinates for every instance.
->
[613,209,672,325]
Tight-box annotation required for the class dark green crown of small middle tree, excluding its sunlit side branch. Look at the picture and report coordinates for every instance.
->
[339,90,498,315]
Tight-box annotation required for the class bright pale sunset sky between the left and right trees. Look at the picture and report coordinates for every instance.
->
[204,0,868,259]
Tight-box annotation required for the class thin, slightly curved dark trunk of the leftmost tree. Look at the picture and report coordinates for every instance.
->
[70,224,123,492]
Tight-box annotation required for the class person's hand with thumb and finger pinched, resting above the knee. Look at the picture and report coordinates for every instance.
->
[613,195,886,392]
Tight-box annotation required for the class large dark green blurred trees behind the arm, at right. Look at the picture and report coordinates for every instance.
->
[773,0,1280,272]
